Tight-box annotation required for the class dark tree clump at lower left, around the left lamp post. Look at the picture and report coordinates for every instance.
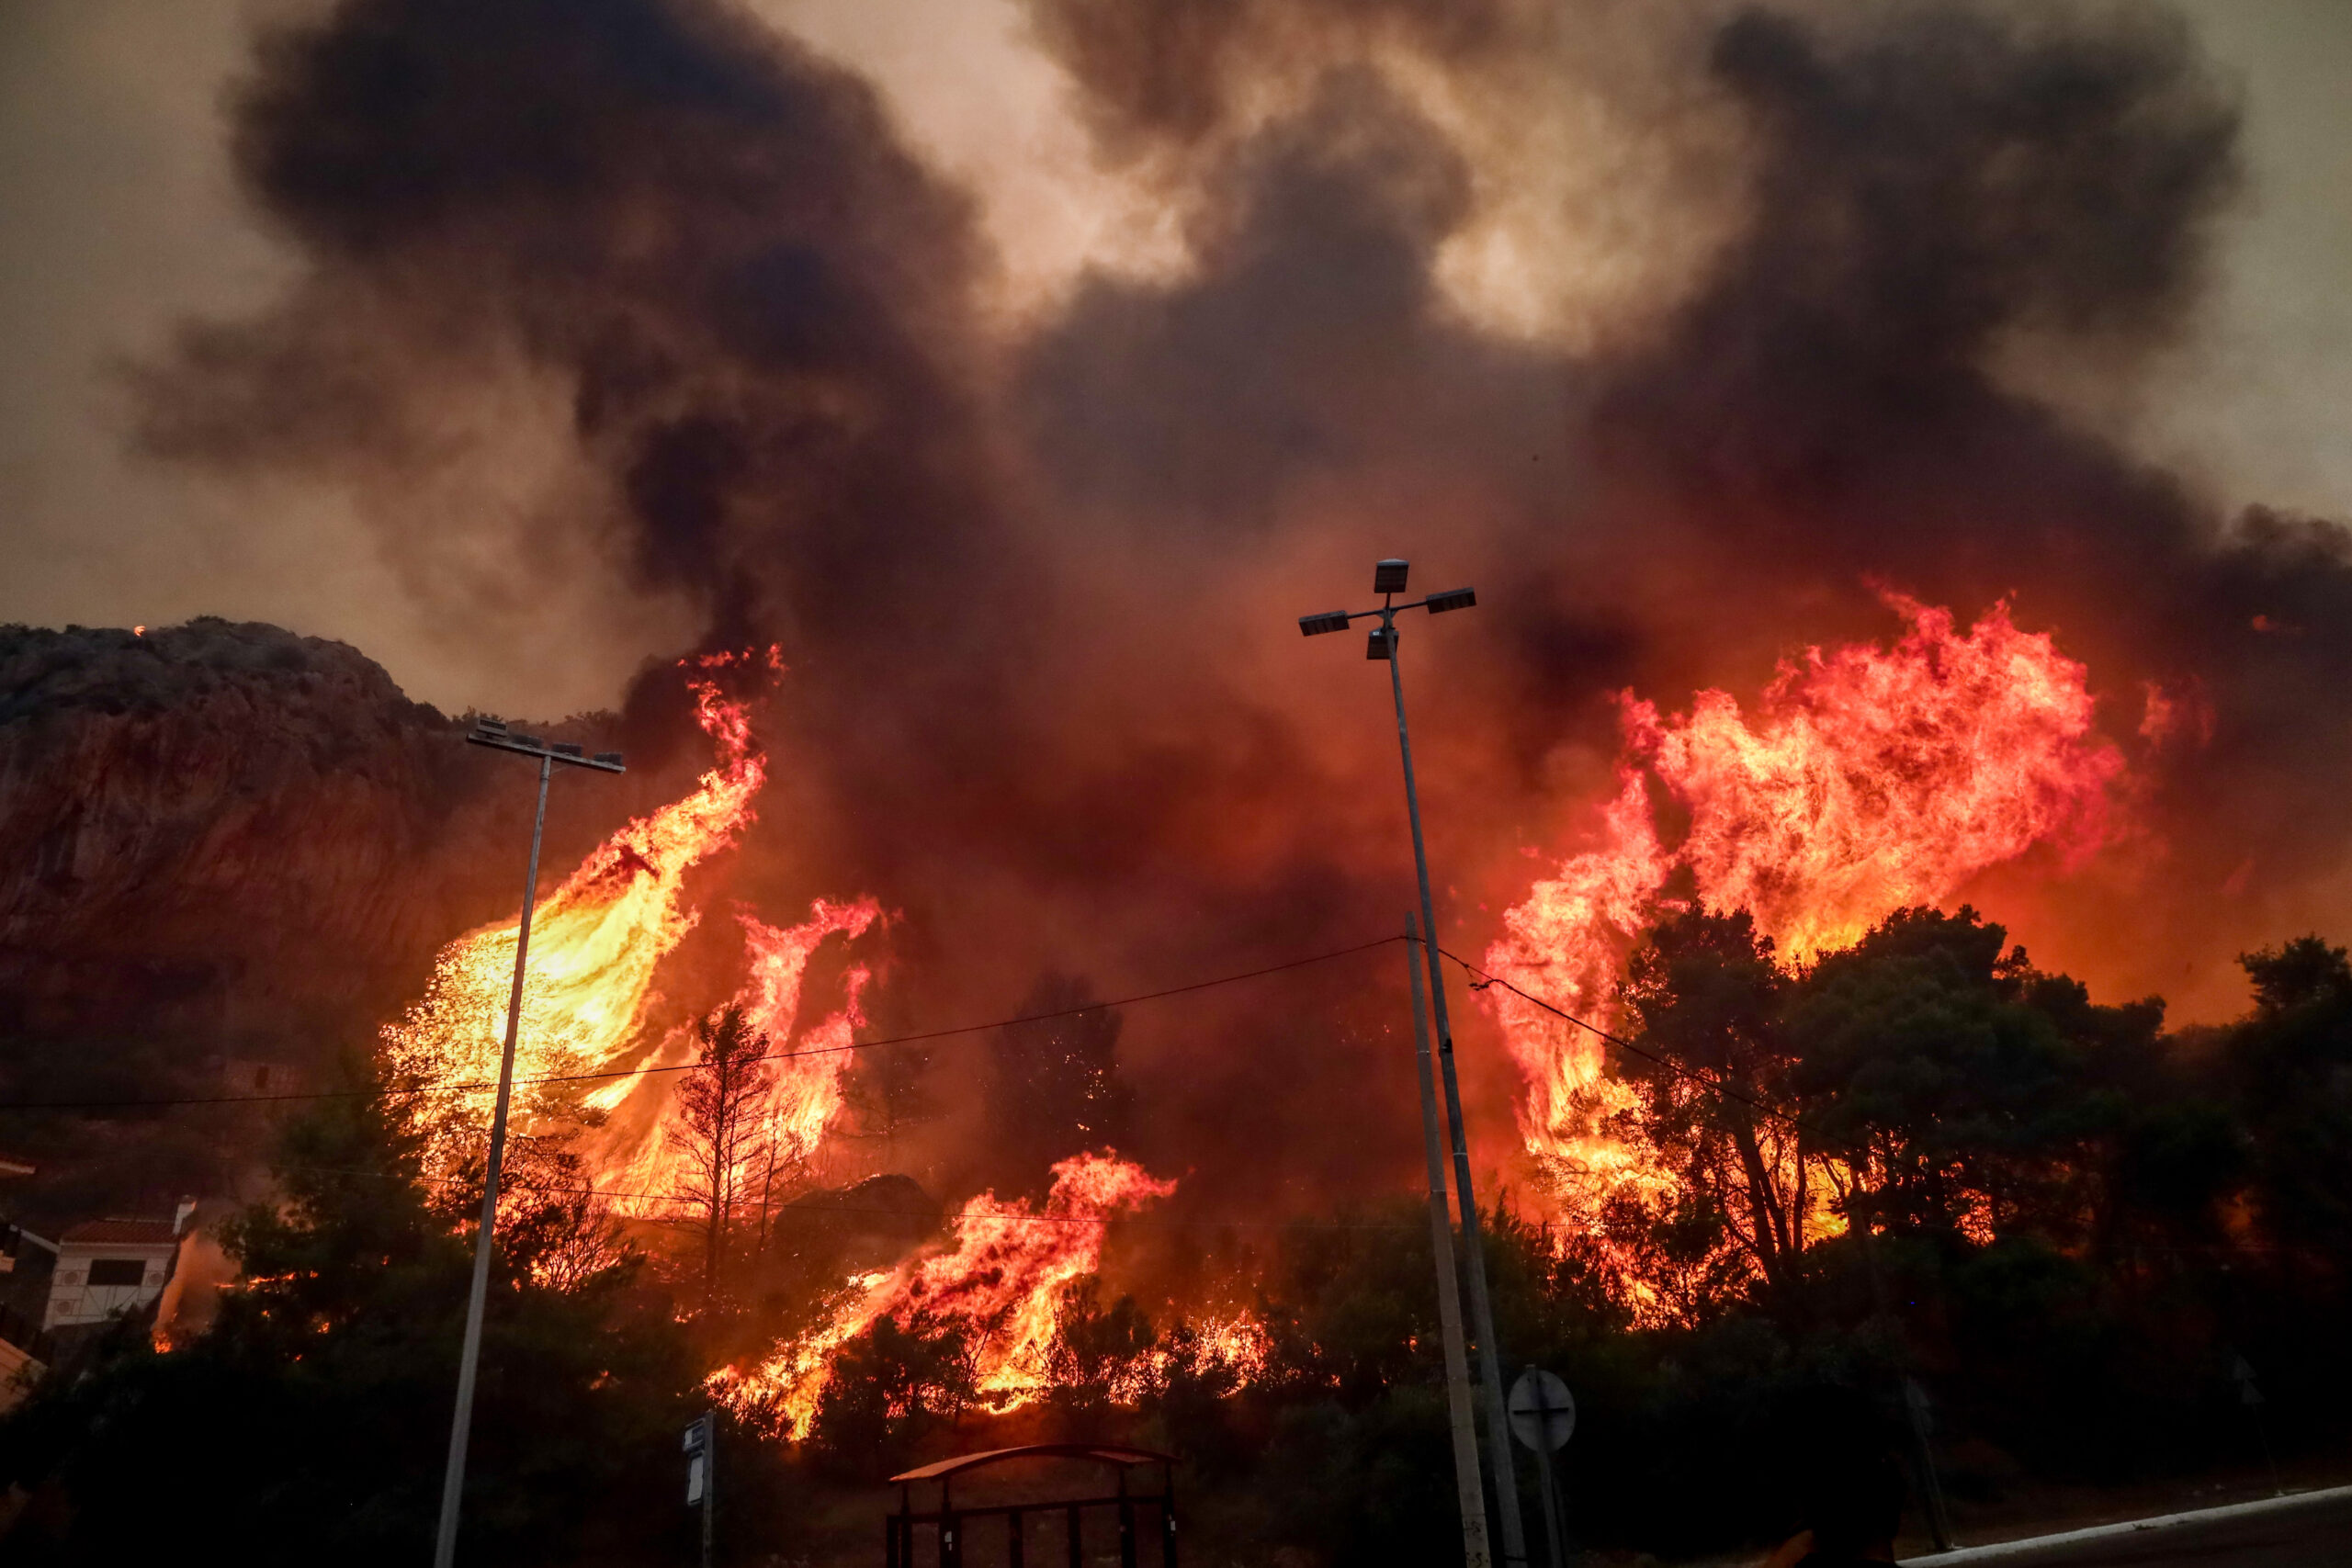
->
[0,1096,694,1563]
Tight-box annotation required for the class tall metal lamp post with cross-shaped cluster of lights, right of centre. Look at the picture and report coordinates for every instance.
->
[1298,559,1526,1563]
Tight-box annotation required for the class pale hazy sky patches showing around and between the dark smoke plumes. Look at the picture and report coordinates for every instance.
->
[0,0,2352,712]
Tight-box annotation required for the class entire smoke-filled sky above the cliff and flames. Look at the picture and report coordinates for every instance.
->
[0,0,2352,1213]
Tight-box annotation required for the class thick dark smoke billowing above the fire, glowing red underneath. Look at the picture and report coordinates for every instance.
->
[146,0,2352,1185]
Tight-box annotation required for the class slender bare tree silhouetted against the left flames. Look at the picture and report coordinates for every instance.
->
[665,1006,776,1304]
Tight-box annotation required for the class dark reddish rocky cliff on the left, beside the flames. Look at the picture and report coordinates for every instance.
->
[0,618,635,1058]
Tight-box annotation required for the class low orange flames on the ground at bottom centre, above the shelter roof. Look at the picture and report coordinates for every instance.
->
[710,1149,1185,1437]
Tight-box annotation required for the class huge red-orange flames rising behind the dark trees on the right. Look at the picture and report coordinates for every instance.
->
[1487,594,2124,1208]
